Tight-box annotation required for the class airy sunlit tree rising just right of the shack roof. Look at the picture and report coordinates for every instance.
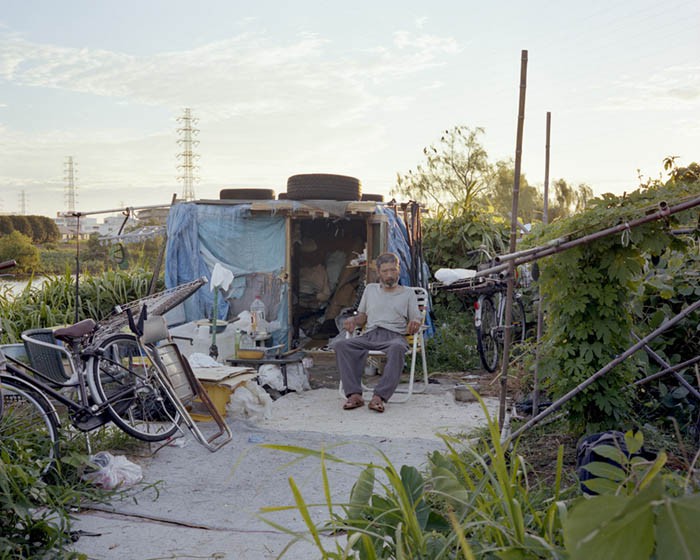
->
[391,125,492,216]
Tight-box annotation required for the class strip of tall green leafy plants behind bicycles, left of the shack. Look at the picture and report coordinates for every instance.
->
[0,270,162,343]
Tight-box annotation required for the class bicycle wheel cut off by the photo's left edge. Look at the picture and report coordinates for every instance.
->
[0,375,61,475]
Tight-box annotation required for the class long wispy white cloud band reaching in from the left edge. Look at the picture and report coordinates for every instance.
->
[0,27,459,122]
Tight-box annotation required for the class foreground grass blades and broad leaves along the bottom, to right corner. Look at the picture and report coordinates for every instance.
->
[261,394,700,560]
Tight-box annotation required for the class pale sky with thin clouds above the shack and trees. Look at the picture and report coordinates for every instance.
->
[0,0,700,216]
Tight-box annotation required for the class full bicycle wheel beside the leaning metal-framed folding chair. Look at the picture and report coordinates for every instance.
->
[88,334,182,441]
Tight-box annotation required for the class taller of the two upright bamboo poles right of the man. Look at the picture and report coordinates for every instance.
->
[498,50,527,429]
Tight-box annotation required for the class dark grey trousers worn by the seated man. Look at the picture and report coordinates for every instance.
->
[333,327,408,401]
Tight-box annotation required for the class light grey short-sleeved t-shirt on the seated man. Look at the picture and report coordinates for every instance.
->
[357,284,421,334]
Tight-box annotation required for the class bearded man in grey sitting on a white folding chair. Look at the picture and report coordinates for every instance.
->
[333,253,421,412]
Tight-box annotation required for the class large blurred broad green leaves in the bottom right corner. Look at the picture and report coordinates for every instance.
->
[564,431,700,560]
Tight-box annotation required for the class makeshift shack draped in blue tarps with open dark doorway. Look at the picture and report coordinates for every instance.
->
[165,179,427,355]
